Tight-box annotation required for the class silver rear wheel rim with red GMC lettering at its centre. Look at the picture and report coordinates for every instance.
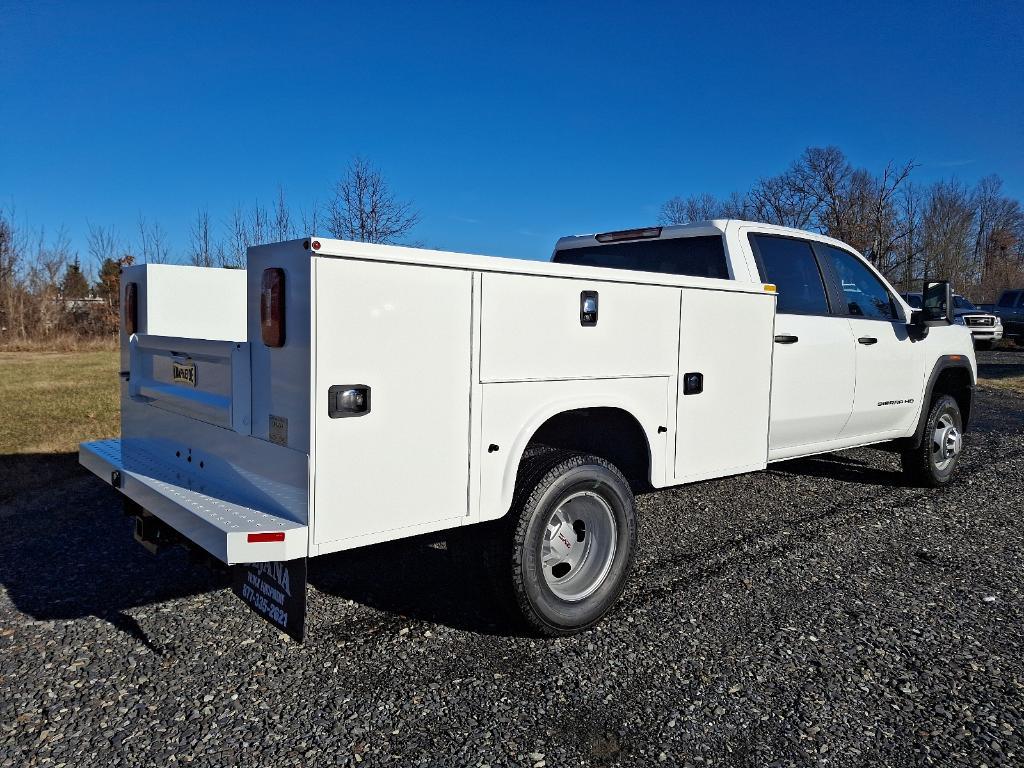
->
[541,490,618,602]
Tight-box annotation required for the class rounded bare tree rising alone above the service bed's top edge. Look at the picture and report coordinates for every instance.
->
[325,158,420,243]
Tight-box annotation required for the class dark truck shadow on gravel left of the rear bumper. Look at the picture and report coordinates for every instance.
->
[0,454,228,653]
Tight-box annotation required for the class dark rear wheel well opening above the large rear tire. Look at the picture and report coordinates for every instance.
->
[526,408,650,488]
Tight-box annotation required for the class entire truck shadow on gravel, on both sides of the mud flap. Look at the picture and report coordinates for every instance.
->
[0,453,519,653]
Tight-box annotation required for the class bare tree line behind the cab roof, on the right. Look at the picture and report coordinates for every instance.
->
[659,146,1024,303]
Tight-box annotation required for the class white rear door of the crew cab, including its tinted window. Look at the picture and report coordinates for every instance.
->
[749,232,856,456]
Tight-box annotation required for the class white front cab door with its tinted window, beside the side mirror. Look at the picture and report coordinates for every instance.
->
[815,243,925,438]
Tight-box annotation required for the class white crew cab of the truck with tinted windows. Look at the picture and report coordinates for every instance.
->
[552,220,977,468]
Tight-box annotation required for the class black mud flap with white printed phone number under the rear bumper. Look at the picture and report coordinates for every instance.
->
[231,557,306,643]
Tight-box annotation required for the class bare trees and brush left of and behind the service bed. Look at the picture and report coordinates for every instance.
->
[0,158,420,344]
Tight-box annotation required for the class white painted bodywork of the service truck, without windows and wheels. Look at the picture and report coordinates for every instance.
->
[81,221,975,638]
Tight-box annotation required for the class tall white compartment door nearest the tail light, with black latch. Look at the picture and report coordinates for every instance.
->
[313,258,472,549]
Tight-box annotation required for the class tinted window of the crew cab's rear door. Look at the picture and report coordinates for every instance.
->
[751,234,828,314]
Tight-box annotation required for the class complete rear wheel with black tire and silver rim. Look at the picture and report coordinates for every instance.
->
[506,452,637,636]
